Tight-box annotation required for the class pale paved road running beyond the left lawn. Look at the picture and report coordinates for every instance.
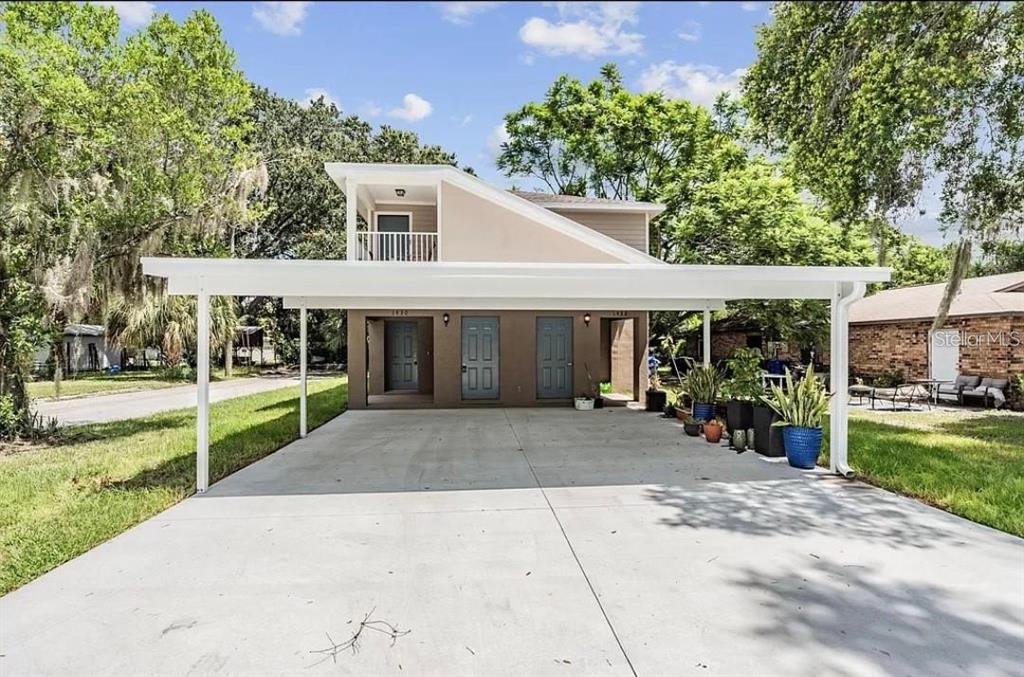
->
[33,376,299,425]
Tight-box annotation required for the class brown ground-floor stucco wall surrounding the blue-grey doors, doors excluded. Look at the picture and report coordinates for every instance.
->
[348,309,647,409]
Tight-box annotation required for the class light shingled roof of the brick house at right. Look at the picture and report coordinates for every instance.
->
[850,271,1024,324]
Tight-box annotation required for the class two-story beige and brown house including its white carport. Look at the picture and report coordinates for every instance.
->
[142,163,890,492]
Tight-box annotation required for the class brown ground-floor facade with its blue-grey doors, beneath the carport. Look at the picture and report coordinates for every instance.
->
[348,309,647,409]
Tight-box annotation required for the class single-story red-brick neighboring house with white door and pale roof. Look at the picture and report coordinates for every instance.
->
[850,271,1024,381]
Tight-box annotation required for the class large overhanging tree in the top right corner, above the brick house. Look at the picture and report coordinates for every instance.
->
[743,1,1024,327]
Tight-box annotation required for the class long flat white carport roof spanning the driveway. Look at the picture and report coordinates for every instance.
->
[142,258,890,310]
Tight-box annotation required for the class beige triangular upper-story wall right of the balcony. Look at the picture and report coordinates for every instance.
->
[439,182,622,263]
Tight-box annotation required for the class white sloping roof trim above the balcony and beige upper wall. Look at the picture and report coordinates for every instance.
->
[324,162,665,265]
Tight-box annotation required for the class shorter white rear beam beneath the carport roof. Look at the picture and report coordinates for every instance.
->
[284,296,725,311]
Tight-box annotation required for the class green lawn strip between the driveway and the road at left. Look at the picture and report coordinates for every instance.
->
[0,377,348,595]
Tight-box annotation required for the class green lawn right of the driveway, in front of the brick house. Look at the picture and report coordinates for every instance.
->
[821,410,1024,537]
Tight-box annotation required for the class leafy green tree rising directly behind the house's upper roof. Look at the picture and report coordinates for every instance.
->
[498,64,744,257]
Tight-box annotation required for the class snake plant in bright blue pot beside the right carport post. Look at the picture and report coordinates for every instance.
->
[768,365,828,470]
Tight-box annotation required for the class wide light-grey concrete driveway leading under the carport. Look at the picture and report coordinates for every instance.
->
[0,410,1024,677]
